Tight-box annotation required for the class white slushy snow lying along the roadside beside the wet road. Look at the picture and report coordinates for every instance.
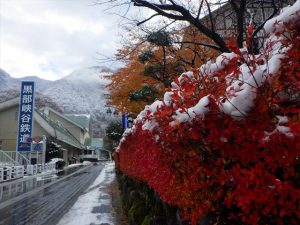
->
[57,163,115,225]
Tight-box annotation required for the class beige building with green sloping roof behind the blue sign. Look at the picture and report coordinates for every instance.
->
[0,98,90,163]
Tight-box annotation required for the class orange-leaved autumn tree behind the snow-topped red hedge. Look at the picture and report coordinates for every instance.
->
[108,27,217,114]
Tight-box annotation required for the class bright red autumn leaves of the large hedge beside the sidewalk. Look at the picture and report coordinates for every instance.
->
[115,5,300,225]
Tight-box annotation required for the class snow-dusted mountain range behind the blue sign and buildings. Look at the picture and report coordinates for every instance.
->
[0,66,115,136]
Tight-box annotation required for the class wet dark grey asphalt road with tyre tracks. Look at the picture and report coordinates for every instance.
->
[0,164,104,225]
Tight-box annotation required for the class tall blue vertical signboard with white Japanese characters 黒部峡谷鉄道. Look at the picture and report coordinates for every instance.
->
[17,81,34,152]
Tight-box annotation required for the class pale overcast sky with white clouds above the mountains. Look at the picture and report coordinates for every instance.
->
[0,0,120,80]
